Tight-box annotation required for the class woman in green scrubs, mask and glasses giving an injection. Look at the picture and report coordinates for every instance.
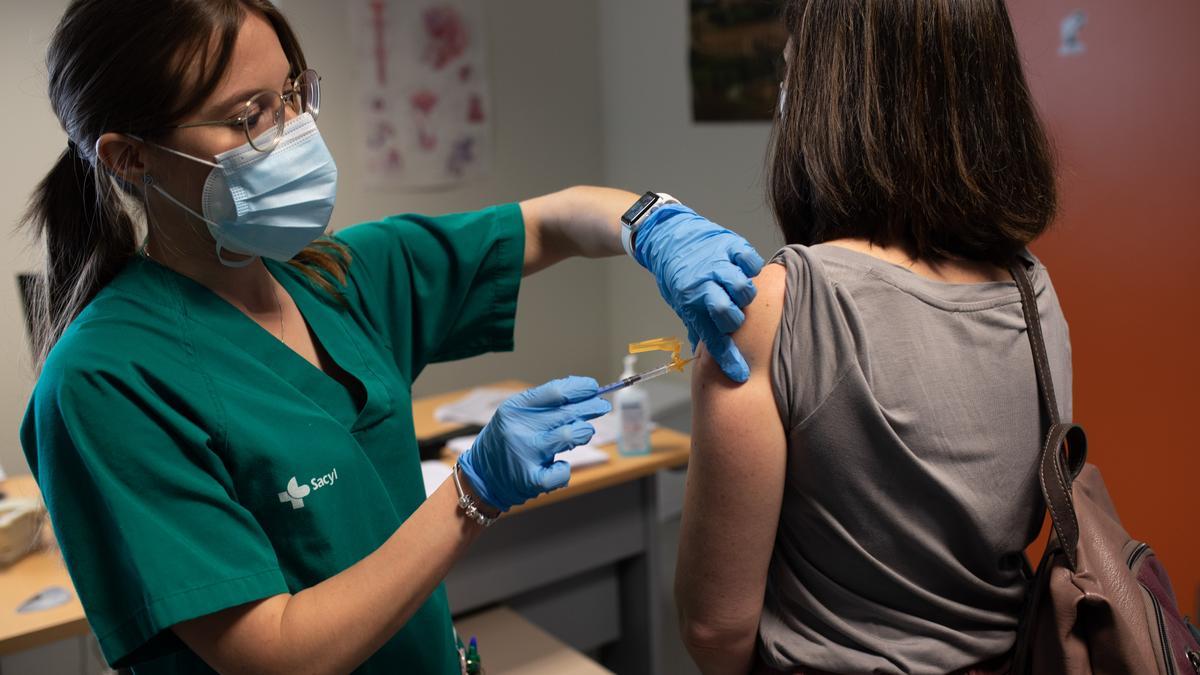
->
[22,0,762,675]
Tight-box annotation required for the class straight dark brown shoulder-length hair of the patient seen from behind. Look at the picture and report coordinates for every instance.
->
[769,0,1055,263]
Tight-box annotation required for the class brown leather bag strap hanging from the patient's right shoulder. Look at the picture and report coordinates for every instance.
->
[1008,259,1087,569]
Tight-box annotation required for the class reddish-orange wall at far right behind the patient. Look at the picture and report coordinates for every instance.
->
[1008,0,1200,616]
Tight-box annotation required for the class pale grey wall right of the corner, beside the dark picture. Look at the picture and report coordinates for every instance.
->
[600,0,782,362]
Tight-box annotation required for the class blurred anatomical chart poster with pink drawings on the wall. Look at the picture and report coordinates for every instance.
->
[349,0,492,189]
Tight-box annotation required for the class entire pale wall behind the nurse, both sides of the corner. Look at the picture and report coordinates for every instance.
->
[0,0,781,472]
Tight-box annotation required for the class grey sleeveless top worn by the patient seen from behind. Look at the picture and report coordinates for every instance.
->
[758,245,1072,673]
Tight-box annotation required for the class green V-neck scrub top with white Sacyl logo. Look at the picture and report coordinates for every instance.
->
[20,204,524,675]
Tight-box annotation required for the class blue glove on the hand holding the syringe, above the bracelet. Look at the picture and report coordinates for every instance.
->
[458,376,612,510]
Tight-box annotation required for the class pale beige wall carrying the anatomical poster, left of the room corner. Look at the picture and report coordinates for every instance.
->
[0,0,608,472]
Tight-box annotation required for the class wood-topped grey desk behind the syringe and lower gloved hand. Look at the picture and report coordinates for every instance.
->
[436,381,691,675]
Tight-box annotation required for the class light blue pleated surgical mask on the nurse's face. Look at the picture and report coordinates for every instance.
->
[138,113,337,267]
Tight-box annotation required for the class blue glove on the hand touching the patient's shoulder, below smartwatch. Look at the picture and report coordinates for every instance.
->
[634,204,763,382]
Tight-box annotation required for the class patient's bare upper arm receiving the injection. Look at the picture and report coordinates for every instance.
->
[677,264,787,634]
